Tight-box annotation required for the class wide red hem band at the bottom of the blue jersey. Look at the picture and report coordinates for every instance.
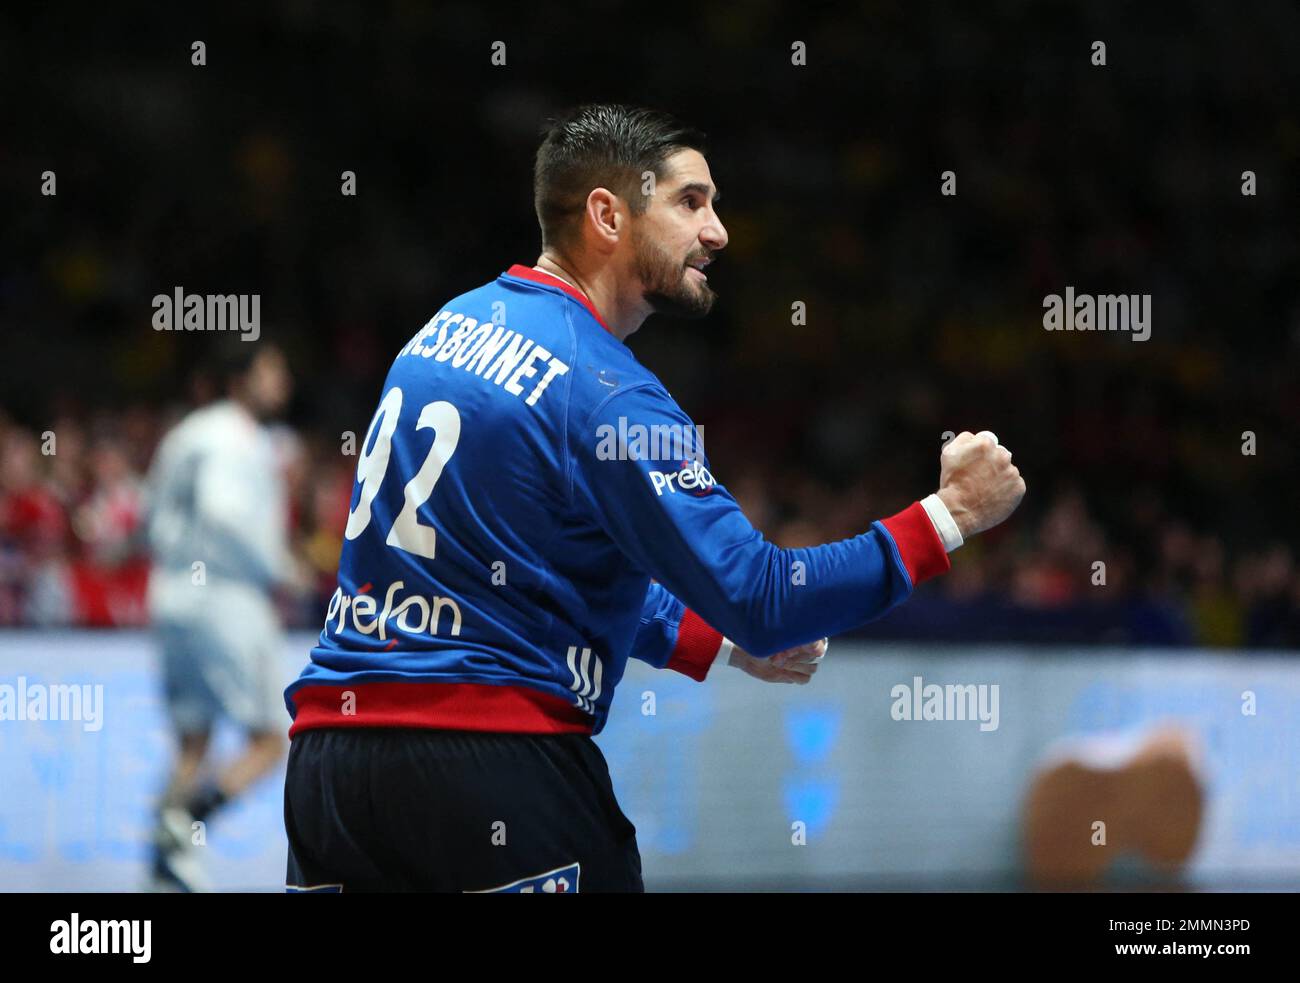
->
[289,683,593,737]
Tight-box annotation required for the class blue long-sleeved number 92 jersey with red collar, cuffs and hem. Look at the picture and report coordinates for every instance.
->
[285,264,949,735]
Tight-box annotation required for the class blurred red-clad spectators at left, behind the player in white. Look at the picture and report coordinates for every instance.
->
[0,406,356,627]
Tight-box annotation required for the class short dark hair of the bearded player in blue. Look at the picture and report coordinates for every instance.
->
[533,103,705,250]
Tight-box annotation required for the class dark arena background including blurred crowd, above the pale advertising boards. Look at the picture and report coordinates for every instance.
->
[0,3,1300,648]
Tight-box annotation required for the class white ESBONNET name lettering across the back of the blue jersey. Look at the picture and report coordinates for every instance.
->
[398,311,569,406]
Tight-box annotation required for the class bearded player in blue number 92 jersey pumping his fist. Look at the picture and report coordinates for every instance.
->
[285,105,1024,892]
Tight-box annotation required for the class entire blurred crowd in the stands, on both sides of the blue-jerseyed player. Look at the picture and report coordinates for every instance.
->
[0,395,1300,648]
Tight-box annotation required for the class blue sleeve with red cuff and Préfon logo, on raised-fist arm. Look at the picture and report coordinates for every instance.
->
[571,382,948,655]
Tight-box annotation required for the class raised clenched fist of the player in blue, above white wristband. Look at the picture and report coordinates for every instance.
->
[939,430,1024,538]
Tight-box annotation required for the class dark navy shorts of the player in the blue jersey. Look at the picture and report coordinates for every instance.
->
[285,727,645,893]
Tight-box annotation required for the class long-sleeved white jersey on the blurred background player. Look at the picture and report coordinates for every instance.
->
[148,400,290,620]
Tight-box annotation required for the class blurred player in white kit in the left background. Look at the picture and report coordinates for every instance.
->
[148,341,294,891]
